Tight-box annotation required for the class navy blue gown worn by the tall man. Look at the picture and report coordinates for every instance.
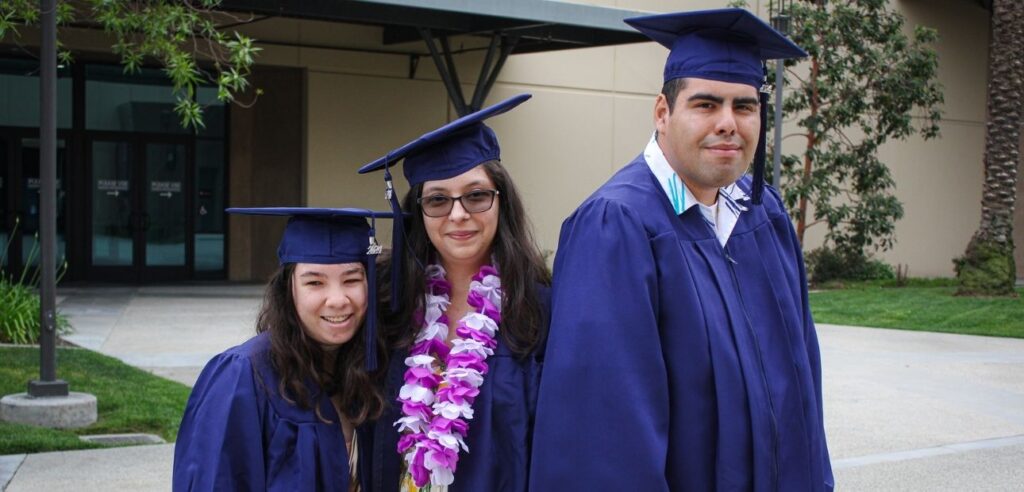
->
[530,156,833,492]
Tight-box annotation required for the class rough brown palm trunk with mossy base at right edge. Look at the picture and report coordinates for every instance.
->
[954,0,1024,295]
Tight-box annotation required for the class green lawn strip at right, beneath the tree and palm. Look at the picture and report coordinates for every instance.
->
[810,279,1024,338]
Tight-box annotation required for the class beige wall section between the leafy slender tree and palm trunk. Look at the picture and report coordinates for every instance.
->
[882,0,991,277]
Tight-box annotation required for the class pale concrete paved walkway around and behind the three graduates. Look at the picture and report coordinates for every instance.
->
[0,285,1024,492]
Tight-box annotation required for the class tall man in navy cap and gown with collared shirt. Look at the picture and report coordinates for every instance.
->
[530,9,834,492]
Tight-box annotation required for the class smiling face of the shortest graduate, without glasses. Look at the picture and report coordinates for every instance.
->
[292,262,367,350]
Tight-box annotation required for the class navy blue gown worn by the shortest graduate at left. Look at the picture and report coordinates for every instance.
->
[173,333,373,492]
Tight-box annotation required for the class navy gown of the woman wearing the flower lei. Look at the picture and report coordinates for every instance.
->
[373,286,550,492]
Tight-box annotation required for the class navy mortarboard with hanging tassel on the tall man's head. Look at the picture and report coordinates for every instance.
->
[626,8,807,205]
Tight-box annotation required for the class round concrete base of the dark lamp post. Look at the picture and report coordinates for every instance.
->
[0,392,96,428]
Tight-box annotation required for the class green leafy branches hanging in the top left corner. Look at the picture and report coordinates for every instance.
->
[0,0,260,128]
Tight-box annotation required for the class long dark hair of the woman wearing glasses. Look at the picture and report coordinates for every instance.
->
[378,161,551,357]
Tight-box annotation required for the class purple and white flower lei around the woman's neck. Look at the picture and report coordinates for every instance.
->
[394,264,502,487]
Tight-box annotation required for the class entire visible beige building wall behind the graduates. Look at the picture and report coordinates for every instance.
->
[276,0,995,277]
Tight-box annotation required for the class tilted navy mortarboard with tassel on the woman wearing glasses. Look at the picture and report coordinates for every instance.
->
[359,94,532,312]
